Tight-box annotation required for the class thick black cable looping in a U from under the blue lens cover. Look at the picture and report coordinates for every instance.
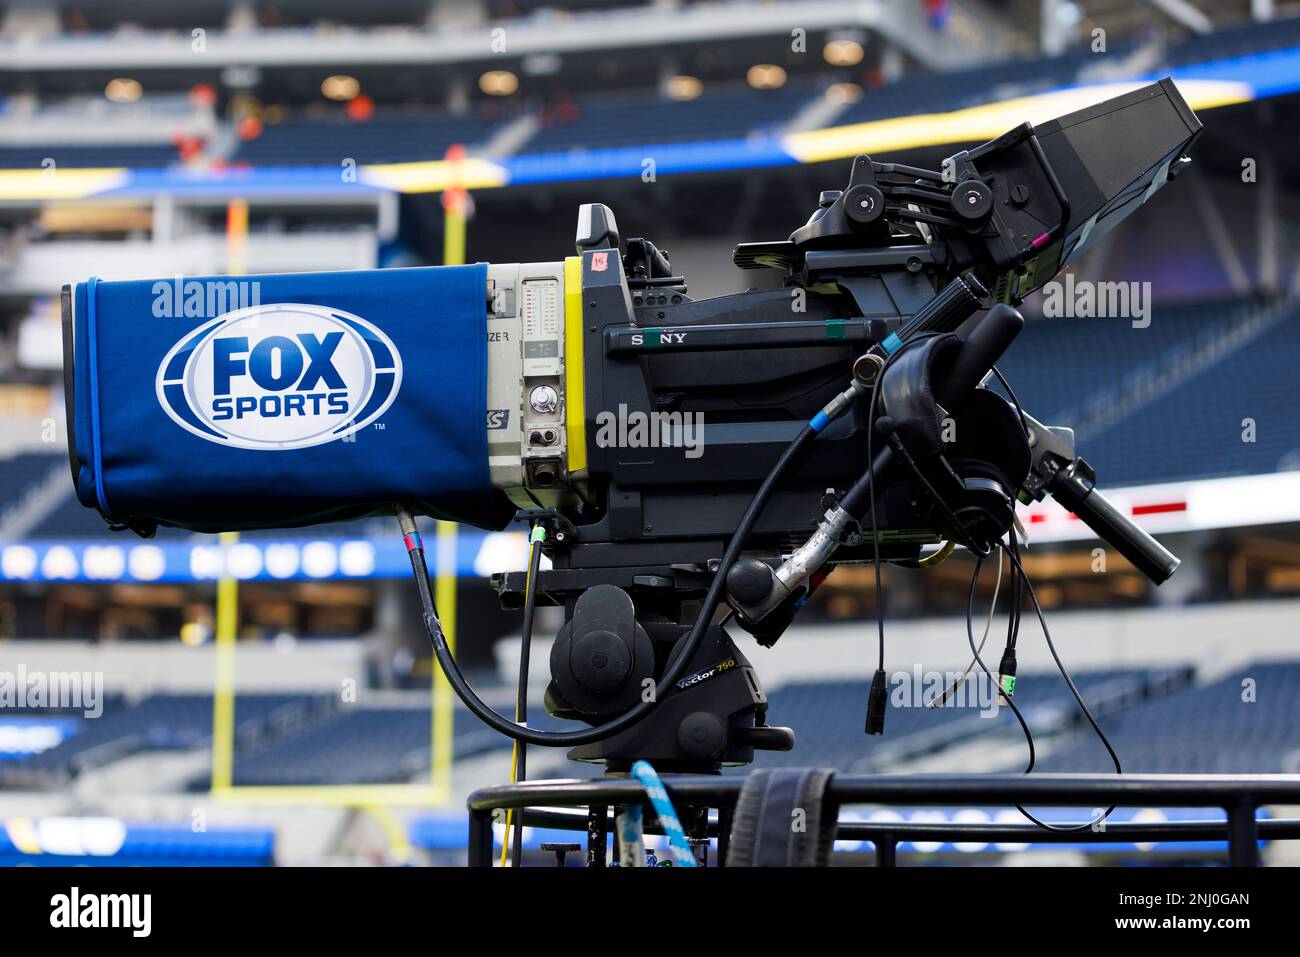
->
[398,425,818,748]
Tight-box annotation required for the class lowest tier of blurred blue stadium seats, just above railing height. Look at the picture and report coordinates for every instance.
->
[0,662,1300,788]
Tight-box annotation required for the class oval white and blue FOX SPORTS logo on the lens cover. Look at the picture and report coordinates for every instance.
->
[157,303,402,450]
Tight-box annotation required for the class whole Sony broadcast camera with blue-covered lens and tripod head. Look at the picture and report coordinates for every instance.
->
[64,79,1200,770]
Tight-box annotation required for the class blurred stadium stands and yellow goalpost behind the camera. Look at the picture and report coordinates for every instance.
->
[0,0,1300,863]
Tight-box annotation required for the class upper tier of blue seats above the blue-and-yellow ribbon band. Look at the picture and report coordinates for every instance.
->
[15,11,1300,174]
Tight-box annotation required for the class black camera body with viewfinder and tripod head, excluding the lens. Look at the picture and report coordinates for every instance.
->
[495,79,1200,770]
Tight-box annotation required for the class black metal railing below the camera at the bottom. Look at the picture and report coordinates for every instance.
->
[467,774,1300,867]
